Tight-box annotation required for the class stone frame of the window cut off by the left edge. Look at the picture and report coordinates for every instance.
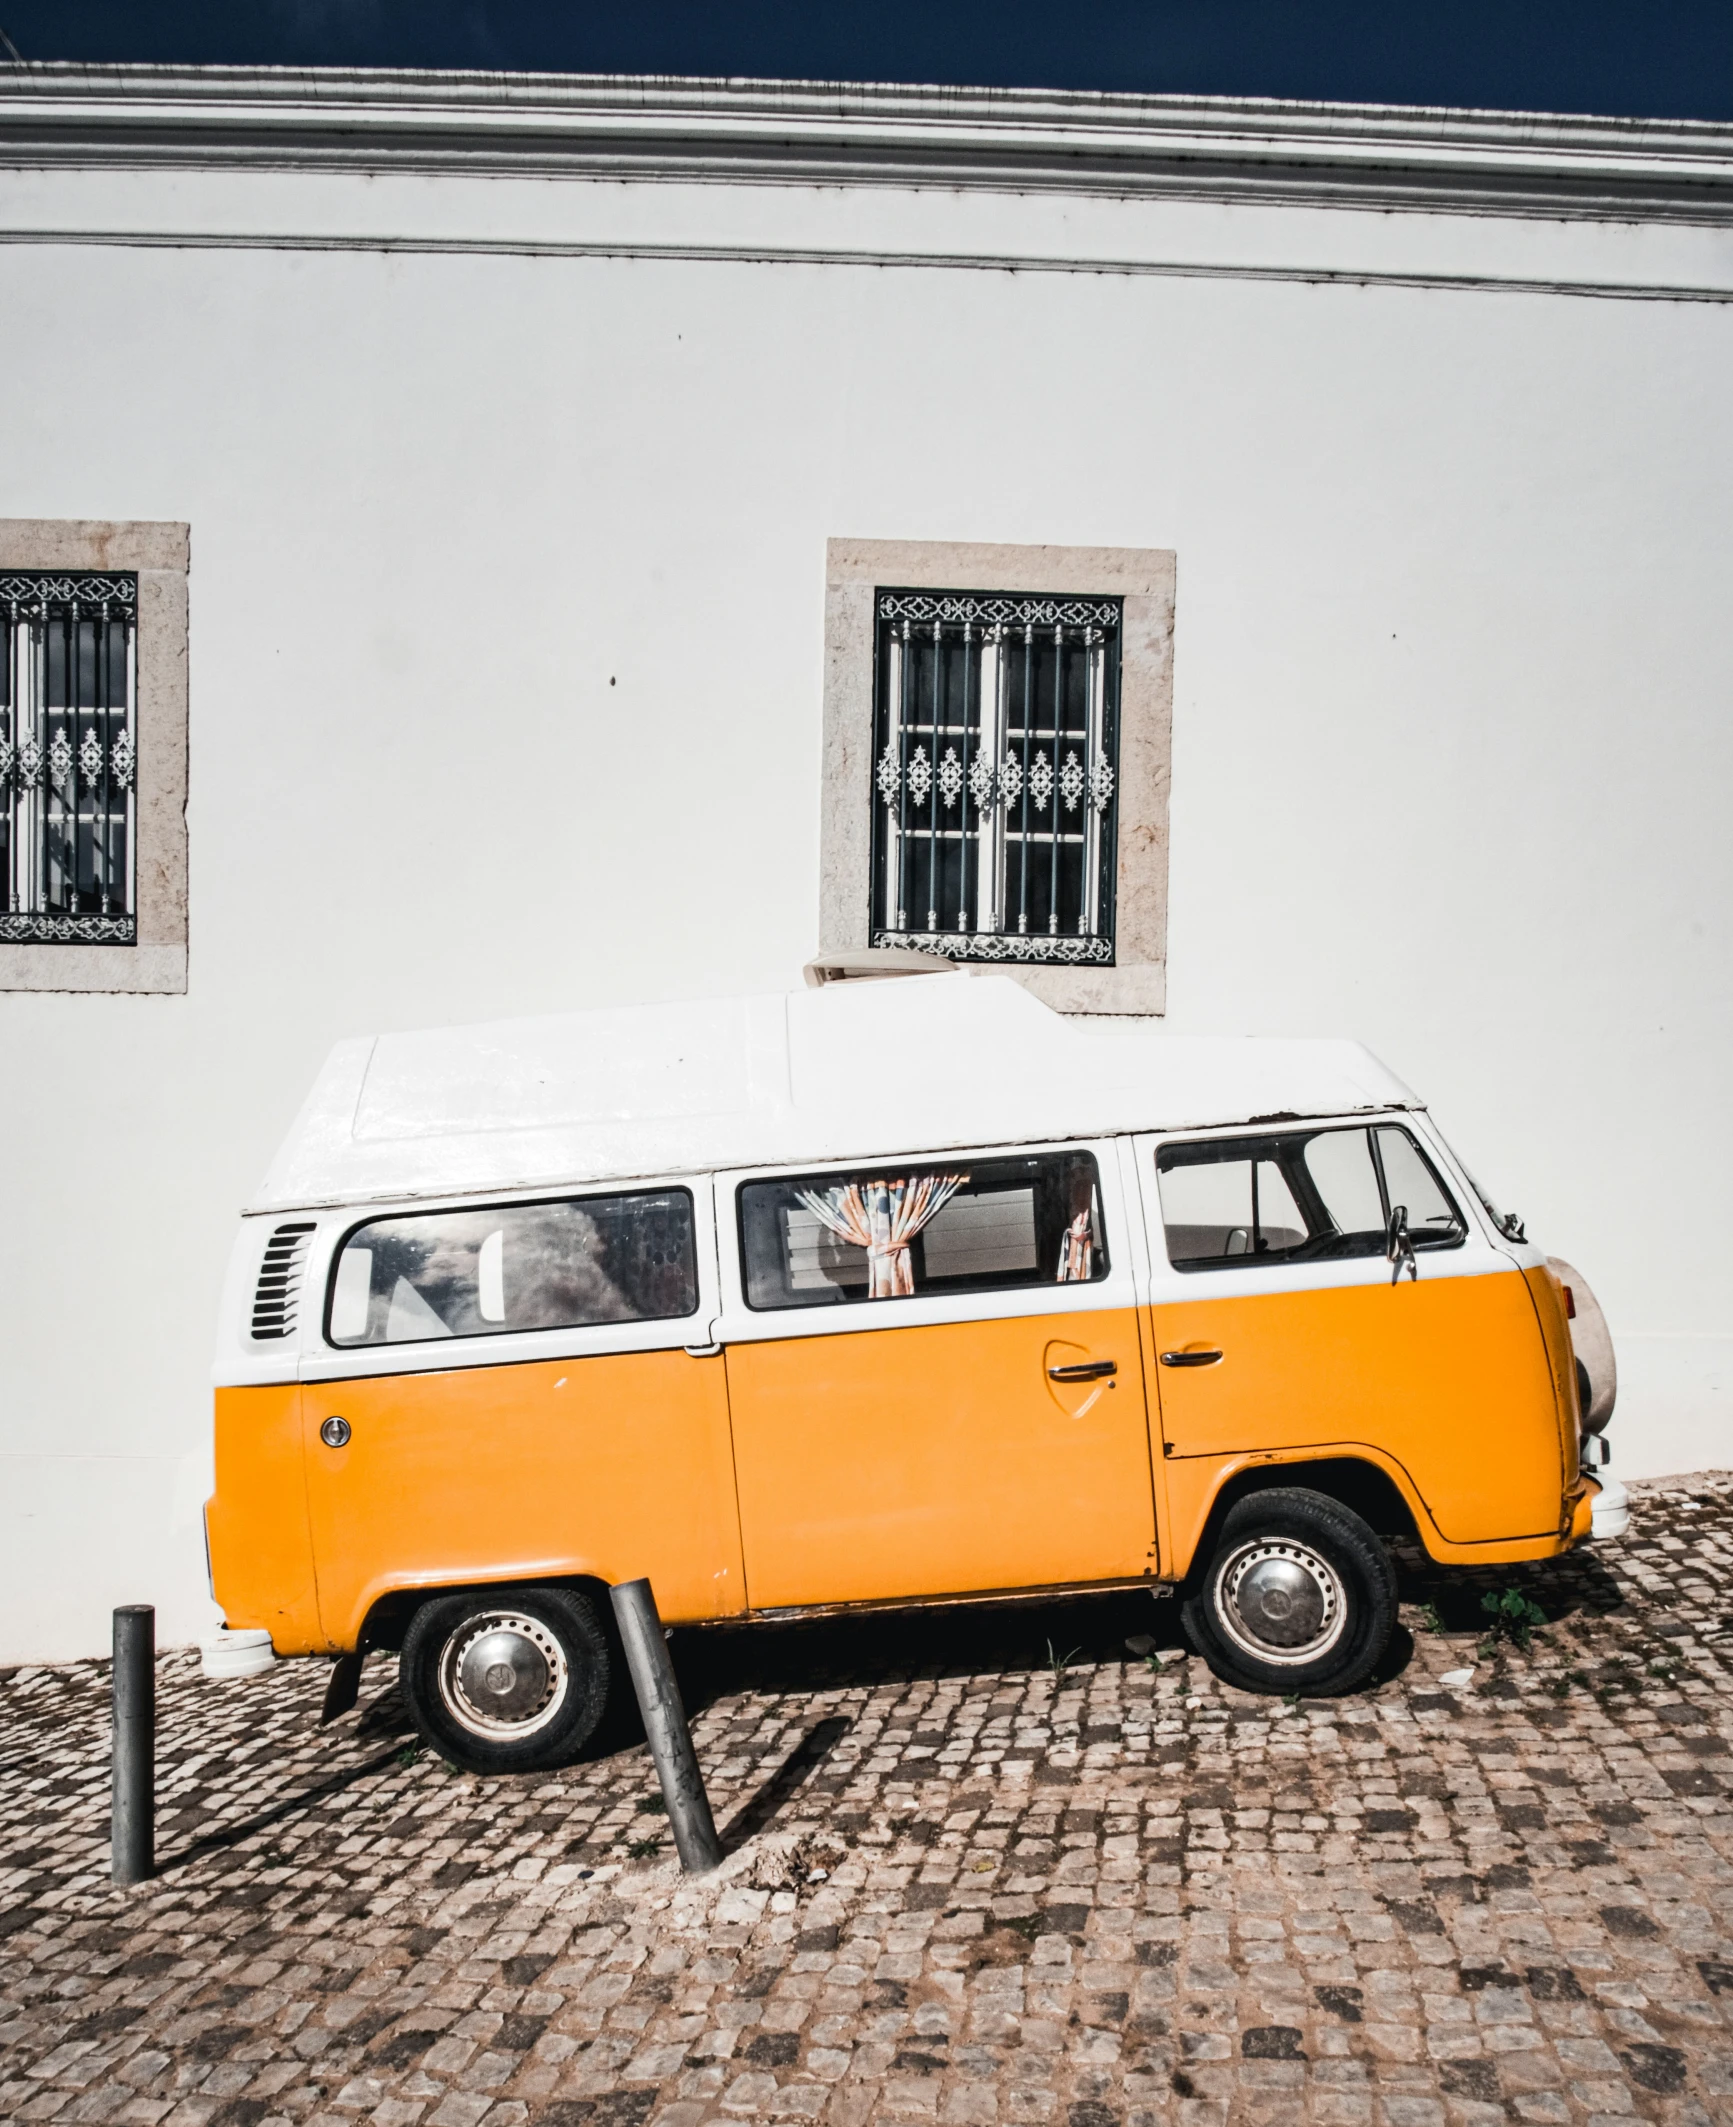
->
[0,517,191,995]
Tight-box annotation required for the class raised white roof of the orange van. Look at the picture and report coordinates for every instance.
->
[251,972,1420,1212]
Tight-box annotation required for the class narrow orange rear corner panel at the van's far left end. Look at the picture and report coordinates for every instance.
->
[206,1383,325,1655]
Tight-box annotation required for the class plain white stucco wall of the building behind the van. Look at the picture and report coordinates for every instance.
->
[0,154,1733,1661]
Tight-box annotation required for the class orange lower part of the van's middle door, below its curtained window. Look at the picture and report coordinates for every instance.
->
[727,1308,1157,1610]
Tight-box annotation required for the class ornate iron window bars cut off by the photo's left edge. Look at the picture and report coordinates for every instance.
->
[0,572,138,944]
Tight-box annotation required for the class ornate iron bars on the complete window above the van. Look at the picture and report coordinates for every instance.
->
[872,591,1123,966]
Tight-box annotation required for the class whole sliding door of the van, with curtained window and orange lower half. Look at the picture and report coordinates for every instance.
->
[719,1146,1155,1610]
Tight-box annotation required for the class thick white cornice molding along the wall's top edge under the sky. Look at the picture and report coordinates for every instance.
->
[0,64,1733,225]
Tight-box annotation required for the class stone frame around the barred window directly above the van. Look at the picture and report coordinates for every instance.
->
[819,538,1176,1015]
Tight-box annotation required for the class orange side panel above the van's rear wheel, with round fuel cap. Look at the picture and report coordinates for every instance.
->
[302,1349,746,1648]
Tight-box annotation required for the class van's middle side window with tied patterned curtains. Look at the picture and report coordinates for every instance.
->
[740,1153,1108,1308]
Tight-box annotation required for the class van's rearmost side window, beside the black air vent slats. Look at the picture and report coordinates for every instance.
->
[327,1189,697,1344]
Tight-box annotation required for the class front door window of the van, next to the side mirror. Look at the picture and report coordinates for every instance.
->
[1157,1123,1467,1270]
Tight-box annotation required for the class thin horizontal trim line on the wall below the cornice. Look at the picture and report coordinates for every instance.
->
[0,228,1733,304]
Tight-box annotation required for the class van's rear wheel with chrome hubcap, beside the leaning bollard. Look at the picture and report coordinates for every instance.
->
[398,1587,615,1772]
